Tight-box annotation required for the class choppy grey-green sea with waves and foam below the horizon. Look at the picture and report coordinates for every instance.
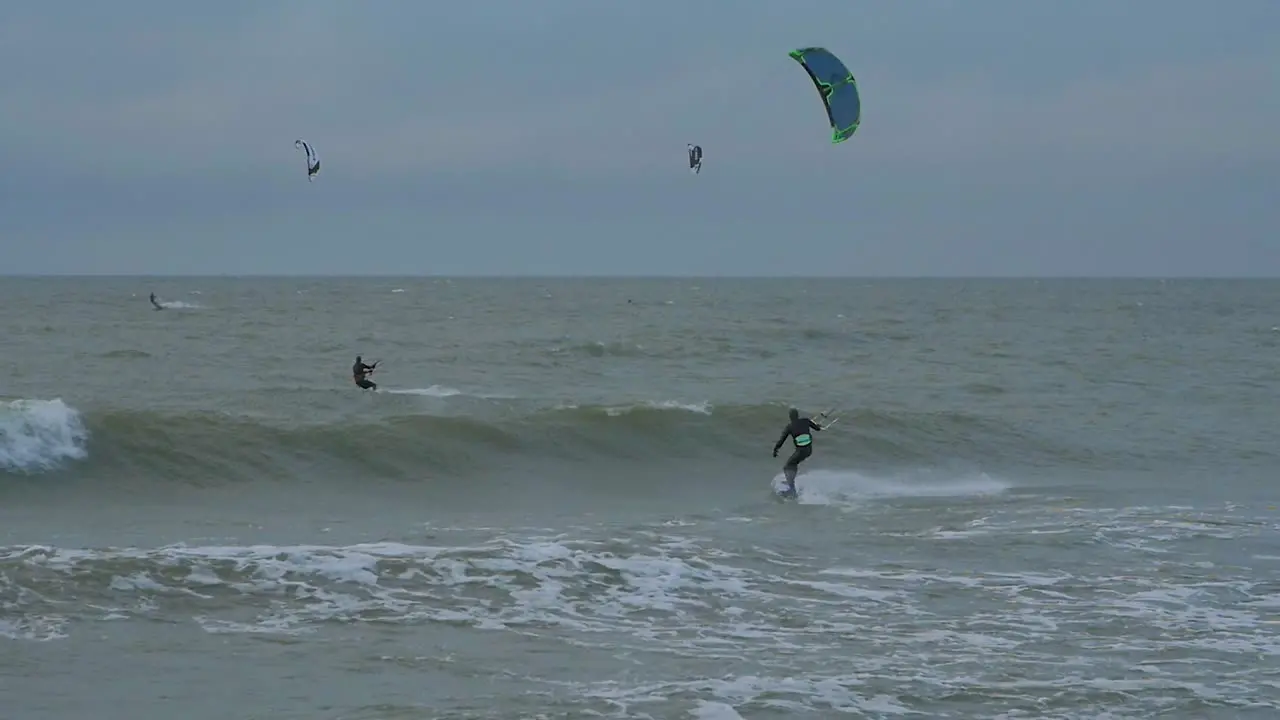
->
[0,277,1280,720]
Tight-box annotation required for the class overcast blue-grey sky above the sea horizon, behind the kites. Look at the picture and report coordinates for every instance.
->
[0,0,1280,277]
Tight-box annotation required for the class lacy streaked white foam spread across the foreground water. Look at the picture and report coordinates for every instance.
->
[10,509,1280,720]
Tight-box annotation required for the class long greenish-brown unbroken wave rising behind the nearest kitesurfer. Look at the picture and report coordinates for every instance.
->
[12,404,1089,486]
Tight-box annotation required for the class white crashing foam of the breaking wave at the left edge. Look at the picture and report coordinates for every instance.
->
[0,398,88,473]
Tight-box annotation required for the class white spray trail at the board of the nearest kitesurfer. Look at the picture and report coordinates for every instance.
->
[772,470,1012,505]
